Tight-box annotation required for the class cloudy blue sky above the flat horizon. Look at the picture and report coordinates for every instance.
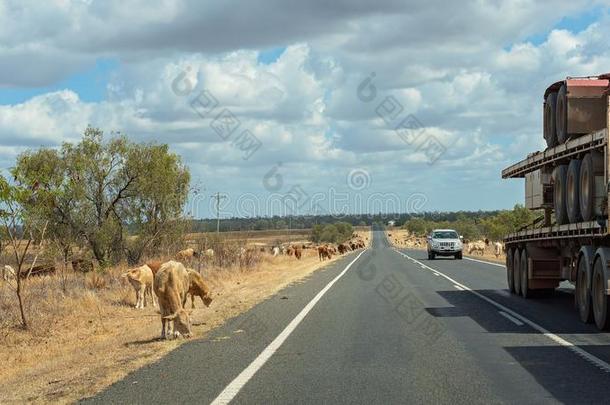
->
[0,0,610,218]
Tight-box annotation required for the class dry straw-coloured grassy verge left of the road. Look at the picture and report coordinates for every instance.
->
[0,231,371,403]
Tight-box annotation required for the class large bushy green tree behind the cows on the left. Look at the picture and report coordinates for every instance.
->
[12,127,190,266]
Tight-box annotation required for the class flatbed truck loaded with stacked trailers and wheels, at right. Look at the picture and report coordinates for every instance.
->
[502,73,610,330]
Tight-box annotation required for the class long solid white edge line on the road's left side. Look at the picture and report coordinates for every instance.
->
[212,249,366,405]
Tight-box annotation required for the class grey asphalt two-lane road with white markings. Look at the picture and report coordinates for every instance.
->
[85,231,610,404]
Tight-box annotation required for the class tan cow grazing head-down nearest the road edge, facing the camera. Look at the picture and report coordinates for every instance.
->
[154,260,192,339]
